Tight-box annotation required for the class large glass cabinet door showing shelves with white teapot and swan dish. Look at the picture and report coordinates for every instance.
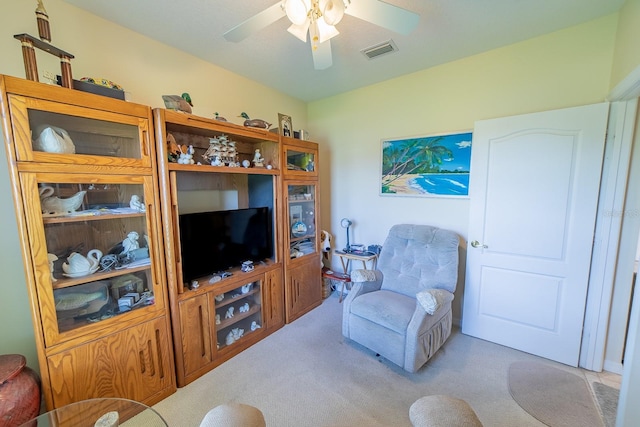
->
[22,173,163,345]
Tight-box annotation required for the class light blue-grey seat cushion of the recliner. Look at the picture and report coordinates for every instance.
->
[351,290,416,335]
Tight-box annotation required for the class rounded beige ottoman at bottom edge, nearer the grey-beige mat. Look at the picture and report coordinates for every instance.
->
[409,395,482,427]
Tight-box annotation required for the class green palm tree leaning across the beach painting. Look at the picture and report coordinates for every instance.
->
[382,137,453,193]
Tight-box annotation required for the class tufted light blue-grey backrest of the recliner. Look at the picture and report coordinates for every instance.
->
[378,224,459,298]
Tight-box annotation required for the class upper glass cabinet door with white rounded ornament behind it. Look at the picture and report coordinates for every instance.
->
[9,95,151,167]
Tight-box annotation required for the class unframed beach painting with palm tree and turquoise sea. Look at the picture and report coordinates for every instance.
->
[380,132,472,197]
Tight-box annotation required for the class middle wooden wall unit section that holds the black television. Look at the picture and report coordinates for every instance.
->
[153,109,290,387]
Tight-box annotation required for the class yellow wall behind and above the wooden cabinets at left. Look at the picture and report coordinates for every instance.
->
[0,0,307,368]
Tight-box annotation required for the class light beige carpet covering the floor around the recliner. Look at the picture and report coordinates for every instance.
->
[154,292,600,427]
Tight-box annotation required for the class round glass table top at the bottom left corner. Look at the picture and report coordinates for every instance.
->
[21,398,168,427]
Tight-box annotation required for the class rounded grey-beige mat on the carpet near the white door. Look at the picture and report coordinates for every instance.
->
[509,361,604,427]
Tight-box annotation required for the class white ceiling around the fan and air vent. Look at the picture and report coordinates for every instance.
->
[65,0,624,101]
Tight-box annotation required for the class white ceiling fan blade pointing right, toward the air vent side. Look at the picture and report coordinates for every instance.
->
[345,0,420,35]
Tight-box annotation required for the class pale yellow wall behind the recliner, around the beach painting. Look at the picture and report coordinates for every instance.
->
[309,15,617,328]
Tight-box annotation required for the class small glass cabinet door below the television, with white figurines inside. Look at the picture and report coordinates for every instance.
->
[214,280,262,350]
